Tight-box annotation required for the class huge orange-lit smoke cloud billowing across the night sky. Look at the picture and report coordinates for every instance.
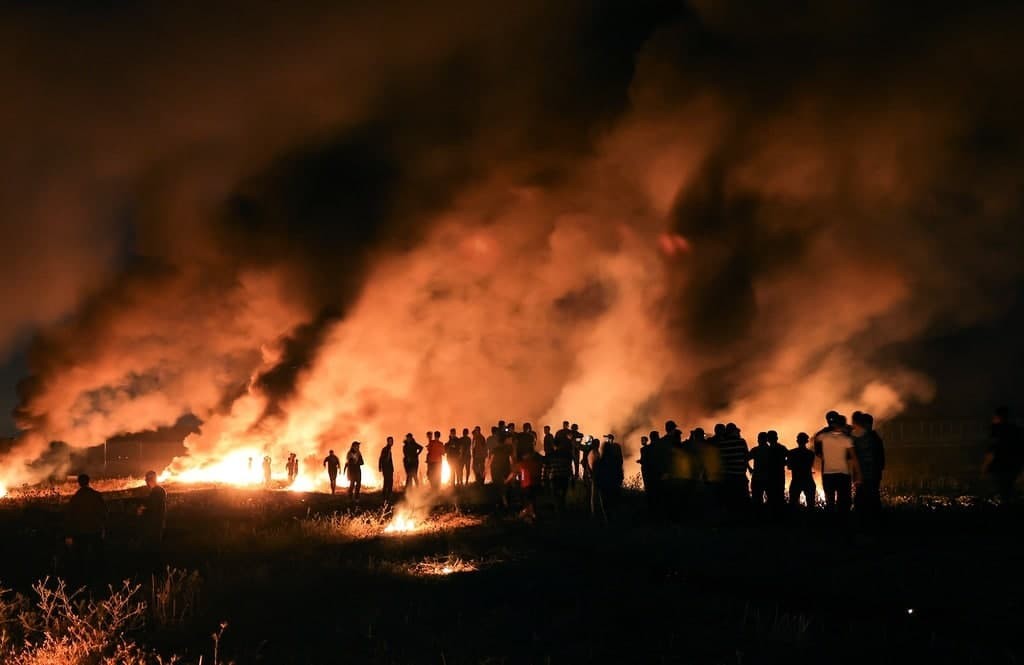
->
[0,2,1024,480]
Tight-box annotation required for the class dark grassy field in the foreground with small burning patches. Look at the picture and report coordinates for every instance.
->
[0,479,1024,665]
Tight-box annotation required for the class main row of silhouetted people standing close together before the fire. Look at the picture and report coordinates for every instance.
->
[339,411,885,519]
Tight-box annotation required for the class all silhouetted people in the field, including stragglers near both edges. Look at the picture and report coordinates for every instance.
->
[59,407,1024,582]
